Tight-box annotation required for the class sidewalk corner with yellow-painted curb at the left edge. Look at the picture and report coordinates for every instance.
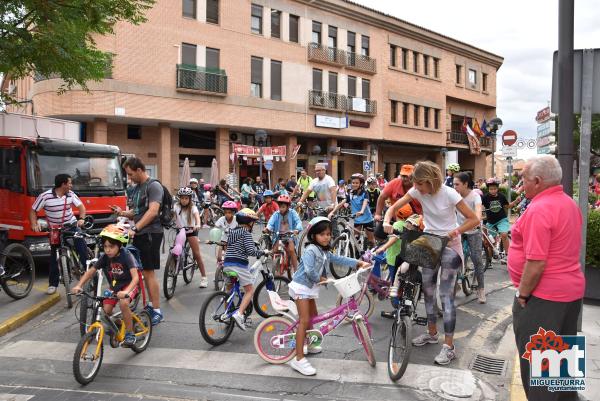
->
[0,275,59,337]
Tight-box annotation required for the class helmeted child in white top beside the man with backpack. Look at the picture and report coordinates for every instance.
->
[173,187,208,288]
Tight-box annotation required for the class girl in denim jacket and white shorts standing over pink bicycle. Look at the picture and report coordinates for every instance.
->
[289,216,369,376]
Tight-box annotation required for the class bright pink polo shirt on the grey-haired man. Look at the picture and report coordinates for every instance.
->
[508,185,585,302]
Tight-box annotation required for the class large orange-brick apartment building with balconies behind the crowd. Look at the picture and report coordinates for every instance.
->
[7,0,503,187]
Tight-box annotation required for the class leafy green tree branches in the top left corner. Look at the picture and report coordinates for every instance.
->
[0,0,155,104]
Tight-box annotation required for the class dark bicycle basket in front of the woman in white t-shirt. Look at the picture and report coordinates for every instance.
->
[400,230,449,269]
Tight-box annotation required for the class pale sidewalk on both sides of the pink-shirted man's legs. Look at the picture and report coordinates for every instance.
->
[510,301,600,401]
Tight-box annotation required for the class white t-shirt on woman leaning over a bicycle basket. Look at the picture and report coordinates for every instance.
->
[407,185,462,235]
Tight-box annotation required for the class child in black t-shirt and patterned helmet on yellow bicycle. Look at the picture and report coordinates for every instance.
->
[72,224,139,348]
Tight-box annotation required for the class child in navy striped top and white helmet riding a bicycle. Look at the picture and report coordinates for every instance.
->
[223,208,269,331]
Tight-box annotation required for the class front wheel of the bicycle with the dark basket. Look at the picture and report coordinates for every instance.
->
[388,310,412,381]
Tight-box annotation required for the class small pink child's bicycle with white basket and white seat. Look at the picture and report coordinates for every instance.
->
[254,267,376,366]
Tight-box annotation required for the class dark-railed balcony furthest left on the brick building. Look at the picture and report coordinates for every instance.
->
[177,64,227,96]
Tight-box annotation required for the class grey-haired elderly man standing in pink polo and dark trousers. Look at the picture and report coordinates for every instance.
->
[508,155,585,401]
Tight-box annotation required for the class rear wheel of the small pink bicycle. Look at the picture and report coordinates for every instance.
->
[254,316,296,365]
